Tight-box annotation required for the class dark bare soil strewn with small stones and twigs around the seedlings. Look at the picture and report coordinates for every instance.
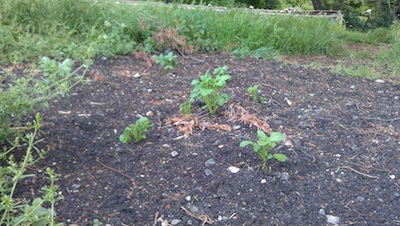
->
[26,53,400,225]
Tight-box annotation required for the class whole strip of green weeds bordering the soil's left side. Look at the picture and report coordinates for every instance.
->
[0,57,91,226]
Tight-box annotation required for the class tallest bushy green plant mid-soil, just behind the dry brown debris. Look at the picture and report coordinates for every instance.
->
[190,66,231,114]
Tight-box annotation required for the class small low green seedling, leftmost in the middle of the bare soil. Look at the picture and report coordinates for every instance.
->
[119,117,153,144]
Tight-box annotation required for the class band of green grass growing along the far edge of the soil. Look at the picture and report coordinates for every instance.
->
[0,0,400,78]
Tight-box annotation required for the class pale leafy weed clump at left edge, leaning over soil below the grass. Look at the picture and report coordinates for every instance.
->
[0,57,91,144]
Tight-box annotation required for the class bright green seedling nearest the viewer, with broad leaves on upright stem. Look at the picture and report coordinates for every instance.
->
[239,130,286,169]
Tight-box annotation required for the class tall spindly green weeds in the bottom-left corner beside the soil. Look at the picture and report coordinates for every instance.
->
[0,114,61,226]
